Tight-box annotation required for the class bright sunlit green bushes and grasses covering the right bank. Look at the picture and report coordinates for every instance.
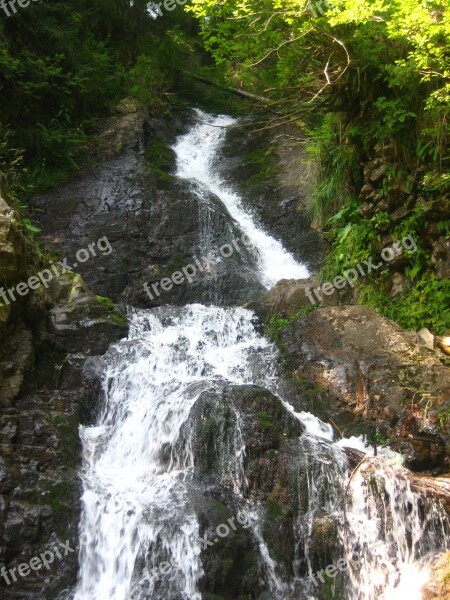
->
[190,0,450,333]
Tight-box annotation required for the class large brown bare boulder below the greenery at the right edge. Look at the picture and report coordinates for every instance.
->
[281,306,450,471]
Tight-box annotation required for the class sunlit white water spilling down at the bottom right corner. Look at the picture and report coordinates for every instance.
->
[344,453,448,600]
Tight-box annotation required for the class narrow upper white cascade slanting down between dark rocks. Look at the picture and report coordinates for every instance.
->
[173,110,309,288]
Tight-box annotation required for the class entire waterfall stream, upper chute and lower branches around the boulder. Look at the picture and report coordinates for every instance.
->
[71,111,448,600]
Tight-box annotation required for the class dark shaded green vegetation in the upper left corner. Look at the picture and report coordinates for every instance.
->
[0,0,236,201]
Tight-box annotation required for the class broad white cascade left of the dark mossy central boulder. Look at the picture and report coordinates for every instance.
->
[75,305,273,600]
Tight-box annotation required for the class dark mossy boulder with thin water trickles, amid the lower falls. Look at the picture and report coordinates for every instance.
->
[176,386,314,598]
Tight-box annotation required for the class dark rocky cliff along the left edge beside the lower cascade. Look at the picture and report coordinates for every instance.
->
[0,180,127,600]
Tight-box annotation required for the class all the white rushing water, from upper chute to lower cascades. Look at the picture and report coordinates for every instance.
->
[73,111,446,600]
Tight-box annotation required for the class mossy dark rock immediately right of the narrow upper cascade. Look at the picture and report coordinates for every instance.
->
[216,122,326,271]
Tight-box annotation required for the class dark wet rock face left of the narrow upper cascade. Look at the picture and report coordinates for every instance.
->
[31,111,264,308]
